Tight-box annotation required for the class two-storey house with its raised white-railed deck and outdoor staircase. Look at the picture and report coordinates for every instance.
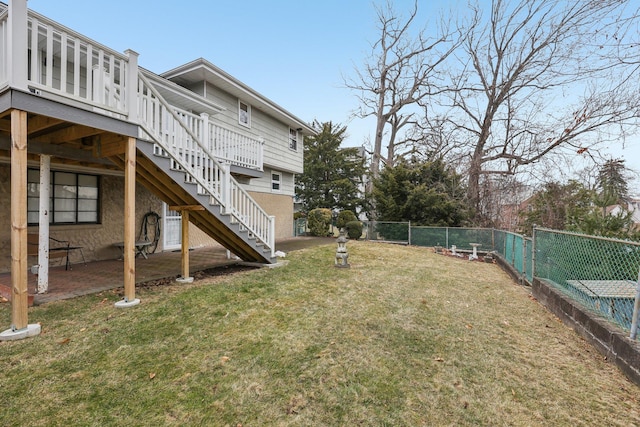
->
[0,0,314,334]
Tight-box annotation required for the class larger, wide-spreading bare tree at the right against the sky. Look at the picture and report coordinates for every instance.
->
[432,0,640,224]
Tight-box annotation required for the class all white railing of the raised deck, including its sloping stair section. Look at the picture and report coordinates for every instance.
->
[0,5,275,254]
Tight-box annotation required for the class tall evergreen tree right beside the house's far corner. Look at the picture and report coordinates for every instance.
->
[296,121,365,212]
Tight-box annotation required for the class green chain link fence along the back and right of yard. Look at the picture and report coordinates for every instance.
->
[296,221,640,339]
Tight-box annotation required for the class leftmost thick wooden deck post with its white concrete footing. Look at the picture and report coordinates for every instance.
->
[0,110,40,341]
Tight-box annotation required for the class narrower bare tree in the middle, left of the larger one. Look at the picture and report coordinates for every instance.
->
[345,0,461,186]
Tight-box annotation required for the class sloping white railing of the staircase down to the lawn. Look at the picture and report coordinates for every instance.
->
[138,73,275,256]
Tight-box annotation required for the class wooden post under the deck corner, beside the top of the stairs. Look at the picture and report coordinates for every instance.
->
[116,138,140,307]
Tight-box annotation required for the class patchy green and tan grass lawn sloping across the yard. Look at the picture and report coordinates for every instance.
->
[0,242,640,427]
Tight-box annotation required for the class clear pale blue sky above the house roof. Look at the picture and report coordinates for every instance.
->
[28,0,640,186]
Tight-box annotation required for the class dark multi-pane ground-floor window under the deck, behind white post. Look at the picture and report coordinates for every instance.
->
[27,169,100,225]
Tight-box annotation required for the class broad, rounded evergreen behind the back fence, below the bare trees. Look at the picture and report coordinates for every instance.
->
[373,158,469,226]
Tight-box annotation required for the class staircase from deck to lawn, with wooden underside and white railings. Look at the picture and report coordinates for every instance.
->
[109,71,276,263]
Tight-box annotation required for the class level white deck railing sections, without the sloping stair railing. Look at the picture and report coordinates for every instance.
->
[0,9,264,171]
